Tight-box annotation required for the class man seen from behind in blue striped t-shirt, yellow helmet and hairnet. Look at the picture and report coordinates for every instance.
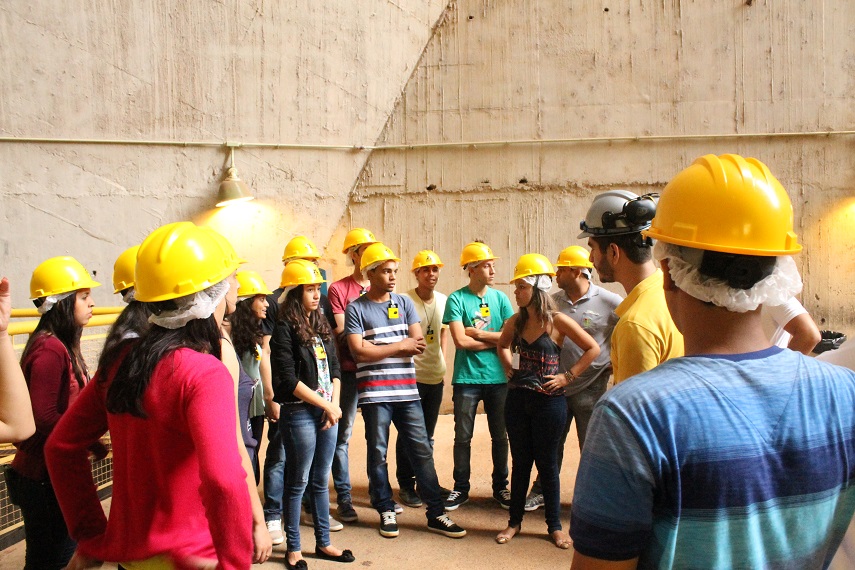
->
[570,155,855,570]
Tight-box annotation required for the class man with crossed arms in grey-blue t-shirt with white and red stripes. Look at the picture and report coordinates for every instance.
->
[344,243,466,538]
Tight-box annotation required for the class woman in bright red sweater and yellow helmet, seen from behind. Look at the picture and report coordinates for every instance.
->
[45,222,253,570]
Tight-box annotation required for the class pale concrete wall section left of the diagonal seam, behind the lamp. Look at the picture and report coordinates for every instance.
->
[0,0,446,306]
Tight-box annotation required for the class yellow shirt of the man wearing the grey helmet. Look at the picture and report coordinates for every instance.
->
[612,269,683,384]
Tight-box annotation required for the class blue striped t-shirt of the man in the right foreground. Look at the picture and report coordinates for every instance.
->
[571,347,855,569]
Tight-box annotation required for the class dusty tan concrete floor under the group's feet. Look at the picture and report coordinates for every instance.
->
[0,415,579,570]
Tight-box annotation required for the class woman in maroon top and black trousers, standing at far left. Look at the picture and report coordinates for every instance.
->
[6,257,100,570]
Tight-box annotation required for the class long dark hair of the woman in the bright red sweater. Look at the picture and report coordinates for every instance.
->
[102,301,220,418]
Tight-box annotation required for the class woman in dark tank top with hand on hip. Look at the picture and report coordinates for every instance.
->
[496,253,600,549]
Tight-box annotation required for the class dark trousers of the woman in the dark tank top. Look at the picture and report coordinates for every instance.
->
[505,388,567,533]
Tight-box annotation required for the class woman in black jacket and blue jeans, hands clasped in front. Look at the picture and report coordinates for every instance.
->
[270,259,355,568]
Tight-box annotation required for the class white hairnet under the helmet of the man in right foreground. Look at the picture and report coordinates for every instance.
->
[653,241,802,313]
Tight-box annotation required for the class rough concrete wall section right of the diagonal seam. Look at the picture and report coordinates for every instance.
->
[333,0,855,336]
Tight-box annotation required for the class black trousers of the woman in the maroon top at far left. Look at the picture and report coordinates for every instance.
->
[6,473,77,570]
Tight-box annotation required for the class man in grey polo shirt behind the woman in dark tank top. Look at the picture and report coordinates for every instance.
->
[525,245,623,511]
